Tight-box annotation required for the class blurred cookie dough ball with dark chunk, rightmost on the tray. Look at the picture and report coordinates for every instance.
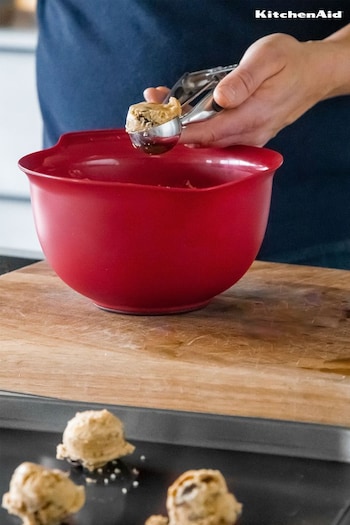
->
[146,469,242,525]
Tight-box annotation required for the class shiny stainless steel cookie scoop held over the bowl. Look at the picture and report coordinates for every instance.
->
[129,64,237,155]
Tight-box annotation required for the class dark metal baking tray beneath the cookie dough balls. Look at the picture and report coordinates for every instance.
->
[0,394,350,525]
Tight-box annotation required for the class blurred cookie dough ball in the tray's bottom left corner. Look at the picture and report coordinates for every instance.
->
[2,462,85,525]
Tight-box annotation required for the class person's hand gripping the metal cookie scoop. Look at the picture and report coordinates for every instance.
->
[144,34,332,147]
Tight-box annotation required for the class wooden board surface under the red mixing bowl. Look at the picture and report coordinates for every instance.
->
[0,261,350,427]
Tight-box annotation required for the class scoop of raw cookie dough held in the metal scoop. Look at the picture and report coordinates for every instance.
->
[125,97,181,133]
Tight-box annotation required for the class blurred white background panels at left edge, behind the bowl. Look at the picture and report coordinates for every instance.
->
[0,28,42,257]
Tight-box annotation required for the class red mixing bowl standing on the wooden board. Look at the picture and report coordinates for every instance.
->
[19,130,282,314]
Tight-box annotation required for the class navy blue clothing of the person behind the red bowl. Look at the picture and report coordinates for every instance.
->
[37,0,350,269]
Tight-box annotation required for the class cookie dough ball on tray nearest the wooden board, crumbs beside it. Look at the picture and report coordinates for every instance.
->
[56,410,135,471]
